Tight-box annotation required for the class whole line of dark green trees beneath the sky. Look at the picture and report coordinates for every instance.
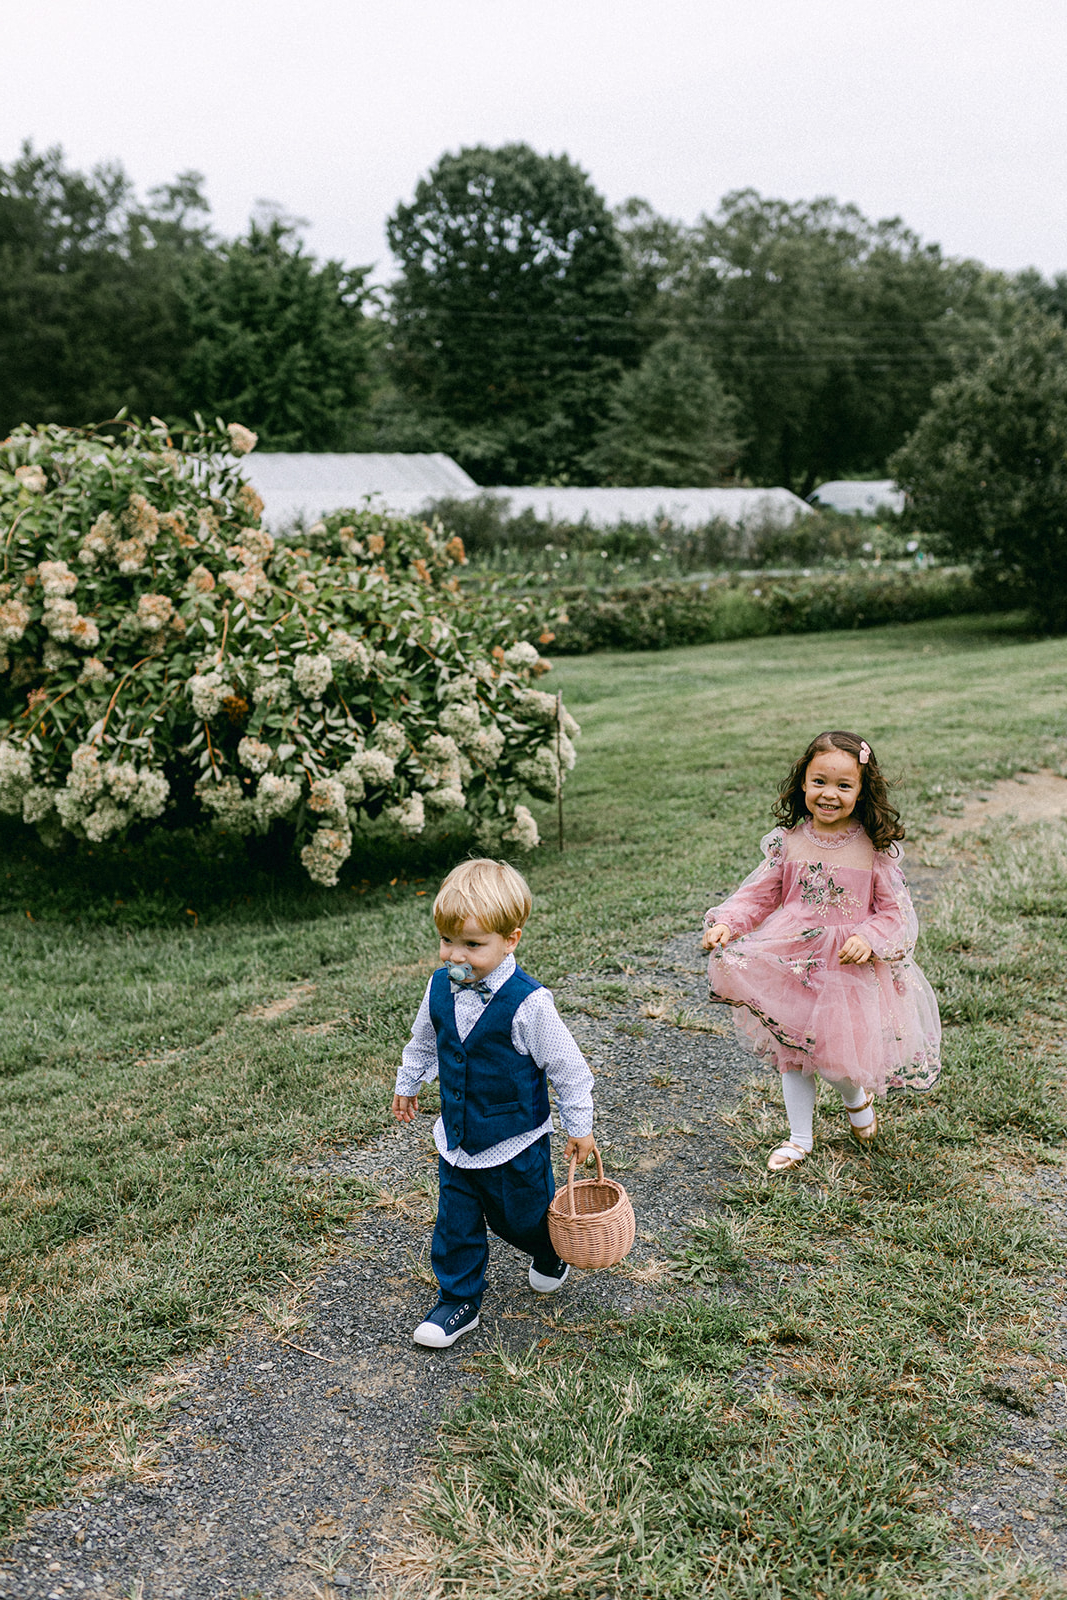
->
[0,144,1067,493]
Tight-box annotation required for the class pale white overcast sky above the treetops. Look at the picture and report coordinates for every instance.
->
[8,0,1067,277]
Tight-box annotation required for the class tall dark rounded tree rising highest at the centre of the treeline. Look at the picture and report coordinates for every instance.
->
[389,144,637,483]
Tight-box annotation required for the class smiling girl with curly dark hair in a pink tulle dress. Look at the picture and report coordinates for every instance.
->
[704,733,941,1173]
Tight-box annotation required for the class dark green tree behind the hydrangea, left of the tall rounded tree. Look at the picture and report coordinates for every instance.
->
[176,214,374,450]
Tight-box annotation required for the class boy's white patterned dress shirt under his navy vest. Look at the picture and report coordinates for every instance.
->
[397,955,593,1168]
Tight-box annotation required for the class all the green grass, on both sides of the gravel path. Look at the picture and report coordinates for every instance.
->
[0,618,1067,1600]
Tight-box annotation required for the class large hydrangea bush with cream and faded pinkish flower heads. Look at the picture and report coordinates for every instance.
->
[0,422,577,885]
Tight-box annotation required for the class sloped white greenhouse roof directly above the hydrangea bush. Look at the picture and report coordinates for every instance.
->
[242,451,477,528]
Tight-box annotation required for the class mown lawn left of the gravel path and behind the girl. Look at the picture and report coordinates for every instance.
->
[0,618,1067,1580]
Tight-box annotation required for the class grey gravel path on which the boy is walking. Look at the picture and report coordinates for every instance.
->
[0,921,1067,1600]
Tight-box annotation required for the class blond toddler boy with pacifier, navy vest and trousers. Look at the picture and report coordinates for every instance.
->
[392,861,593,1350]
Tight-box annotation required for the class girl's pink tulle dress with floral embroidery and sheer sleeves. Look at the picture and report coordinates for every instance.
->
[705,819,941,1094]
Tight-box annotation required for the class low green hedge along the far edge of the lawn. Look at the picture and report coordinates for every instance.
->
[552,566,995,656]
